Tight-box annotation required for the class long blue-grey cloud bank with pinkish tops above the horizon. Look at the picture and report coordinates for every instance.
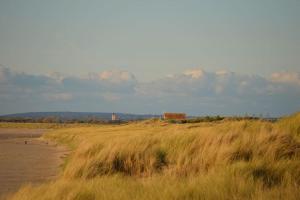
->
[0,66,300,116]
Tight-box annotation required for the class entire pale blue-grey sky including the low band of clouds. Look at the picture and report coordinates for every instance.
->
[0,0,300,116]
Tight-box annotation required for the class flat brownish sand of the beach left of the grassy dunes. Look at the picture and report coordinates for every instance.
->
[0,128,69,199]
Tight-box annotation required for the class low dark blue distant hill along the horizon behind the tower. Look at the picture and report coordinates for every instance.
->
[0,112,159,121]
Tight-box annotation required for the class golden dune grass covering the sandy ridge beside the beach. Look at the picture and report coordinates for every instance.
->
[5,114,300,200]
